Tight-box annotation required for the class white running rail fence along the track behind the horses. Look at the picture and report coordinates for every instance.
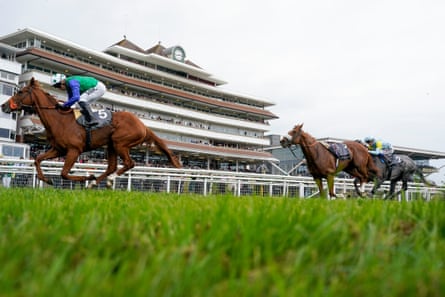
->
[0,159,444,200]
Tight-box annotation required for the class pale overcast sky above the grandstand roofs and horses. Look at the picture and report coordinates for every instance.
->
[0,0,445,182]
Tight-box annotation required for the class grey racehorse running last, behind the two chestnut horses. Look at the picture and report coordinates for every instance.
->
[371,155,431,199]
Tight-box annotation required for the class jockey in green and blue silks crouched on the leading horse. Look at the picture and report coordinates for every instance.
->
[51,73,106,126]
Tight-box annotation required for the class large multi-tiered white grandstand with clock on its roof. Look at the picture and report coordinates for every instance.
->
[0,28,278,171]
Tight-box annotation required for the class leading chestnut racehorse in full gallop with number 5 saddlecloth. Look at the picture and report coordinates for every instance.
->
[2,78,182,187]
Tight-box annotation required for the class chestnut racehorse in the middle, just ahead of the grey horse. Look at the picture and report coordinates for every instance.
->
[280,124,378,197]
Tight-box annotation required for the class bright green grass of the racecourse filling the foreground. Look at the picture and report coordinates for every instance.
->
[0,188,445,297]
